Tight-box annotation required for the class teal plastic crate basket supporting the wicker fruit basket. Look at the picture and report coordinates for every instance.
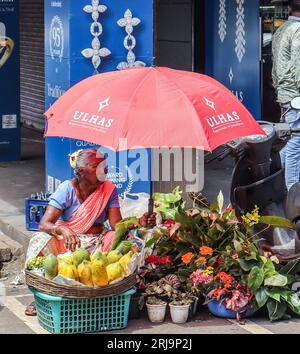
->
[31,289,136,334]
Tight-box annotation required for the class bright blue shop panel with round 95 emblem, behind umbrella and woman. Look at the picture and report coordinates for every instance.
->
[45,0,153,194]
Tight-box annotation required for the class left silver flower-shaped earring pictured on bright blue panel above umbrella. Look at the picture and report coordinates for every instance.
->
[81,0,111,73]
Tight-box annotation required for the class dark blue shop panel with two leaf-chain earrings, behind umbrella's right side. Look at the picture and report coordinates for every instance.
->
[205,0,261,119]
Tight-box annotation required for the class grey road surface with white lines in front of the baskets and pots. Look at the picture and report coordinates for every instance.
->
[0,286,300,335]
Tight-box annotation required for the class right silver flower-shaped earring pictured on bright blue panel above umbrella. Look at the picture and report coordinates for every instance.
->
[117,9,146,70]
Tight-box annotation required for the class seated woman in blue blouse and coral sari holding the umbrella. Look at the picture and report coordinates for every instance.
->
[26,149,156,315]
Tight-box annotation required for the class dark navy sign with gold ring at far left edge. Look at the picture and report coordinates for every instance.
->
[0,0,21,161]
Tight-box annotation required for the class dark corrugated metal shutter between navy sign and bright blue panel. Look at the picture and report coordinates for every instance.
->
[20,0,45,130]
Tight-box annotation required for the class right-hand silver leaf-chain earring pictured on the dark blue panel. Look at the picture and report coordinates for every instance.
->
[235,0,246,63]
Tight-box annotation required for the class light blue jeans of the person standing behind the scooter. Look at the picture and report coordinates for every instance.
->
[281,110,300,189]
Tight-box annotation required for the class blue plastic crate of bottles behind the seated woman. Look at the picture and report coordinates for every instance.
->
[25,198,49,231]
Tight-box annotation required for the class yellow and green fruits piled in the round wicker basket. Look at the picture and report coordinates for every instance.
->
[40,241,134,287]
